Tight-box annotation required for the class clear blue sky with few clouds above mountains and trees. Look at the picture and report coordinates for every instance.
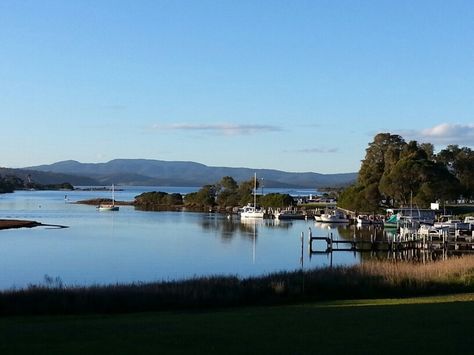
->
[0,0,474,173]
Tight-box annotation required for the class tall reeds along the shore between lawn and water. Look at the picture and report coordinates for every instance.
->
[0,256,474,315]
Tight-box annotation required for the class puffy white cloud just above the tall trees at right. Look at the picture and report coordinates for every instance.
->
[399,123,474,146]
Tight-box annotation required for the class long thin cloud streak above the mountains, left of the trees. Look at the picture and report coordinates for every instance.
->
[152,123,282,135]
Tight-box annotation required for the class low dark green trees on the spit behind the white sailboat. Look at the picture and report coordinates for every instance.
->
[134,176,294,210]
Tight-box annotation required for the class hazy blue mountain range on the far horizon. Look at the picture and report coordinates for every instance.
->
[21,159,357,188]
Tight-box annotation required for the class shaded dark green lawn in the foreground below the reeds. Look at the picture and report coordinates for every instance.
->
[0,294,474,355]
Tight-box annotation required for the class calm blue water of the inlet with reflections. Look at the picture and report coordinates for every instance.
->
[0,188,366,289]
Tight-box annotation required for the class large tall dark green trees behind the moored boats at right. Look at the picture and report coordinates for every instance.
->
[338,133,474,212]
